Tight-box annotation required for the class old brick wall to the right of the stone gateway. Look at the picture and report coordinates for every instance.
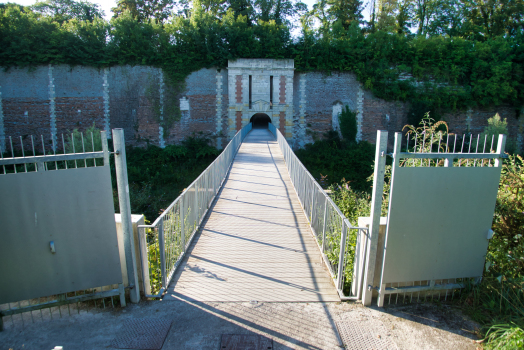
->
[294,72,519,150]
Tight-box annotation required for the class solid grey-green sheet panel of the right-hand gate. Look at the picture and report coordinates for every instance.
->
[382,166,501,284]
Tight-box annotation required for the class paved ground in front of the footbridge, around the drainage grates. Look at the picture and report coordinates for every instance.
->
[0,300,477,350]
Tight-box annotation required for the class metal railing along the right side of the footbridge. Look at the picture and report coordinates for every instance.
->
[268,123,367,300]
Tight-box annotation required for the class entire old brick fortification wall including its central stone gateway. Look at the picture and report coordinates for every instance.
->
[0,59,524,150]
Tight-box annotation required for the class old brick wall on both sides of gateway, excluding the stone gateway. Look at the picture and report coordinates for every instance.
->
[0,66,522,152]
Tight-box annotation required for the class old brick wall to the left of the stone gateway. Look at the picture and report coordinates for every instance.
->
[0,66,223,150]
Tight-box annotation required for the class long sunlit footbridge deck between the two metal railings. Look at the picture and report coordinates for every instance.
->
[168,129,340,302]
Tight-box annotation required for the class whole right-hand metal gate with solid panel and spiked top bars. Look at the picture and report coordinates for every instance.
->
[364,131,506,307]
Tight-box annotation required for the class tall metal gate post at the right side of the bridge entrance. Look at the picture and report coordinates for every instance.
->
[362,130,388,306]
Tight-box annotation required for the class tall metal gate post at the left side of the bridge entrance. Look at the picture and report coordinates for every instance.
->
[113,129,140,303]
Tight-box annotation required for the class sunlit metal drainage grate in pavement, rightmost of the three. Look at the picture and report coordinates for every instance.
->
[336,320,397,350]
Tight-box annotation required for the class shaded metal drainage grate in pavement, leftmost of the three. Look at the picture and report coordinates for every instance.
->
[111,318,173,350]
